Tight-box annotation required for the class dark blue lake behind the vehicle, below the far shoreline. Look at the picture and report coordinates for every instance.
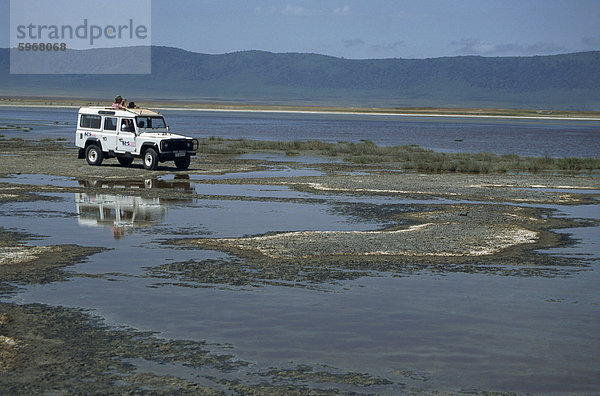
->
[0,107,600,157]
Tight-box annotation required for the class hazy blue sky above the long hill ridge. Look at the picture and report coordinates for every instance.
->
[0,0,600,59]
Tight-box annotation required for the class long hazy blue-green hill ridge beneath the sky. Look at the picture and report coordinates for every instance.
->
[0,47,600,110]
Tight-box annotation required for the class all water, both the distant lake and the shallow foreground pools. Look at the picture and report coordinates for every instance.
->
[0,107,600,394]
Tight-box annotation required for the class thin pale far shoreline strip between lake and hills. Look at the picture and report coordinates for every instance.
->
[0,101,600,122]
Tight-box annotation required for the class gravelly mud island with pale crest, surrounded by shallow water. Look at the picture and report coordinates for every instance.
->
[154,205,591,289]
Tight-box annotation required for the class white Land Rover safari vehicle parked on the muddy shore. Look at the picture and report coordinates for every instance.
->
[75,107,198,169]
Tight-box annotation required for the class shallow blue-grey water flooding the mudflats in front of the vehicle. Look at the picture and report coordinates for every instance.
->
[0,175,600,394]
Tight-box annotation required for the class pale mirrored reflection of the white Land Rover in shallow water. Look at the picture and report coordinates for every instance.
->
[75,193,167,239]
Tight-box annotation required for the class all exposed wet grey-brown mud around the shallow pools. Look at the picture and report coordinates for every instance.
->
[0,139,600,394]
